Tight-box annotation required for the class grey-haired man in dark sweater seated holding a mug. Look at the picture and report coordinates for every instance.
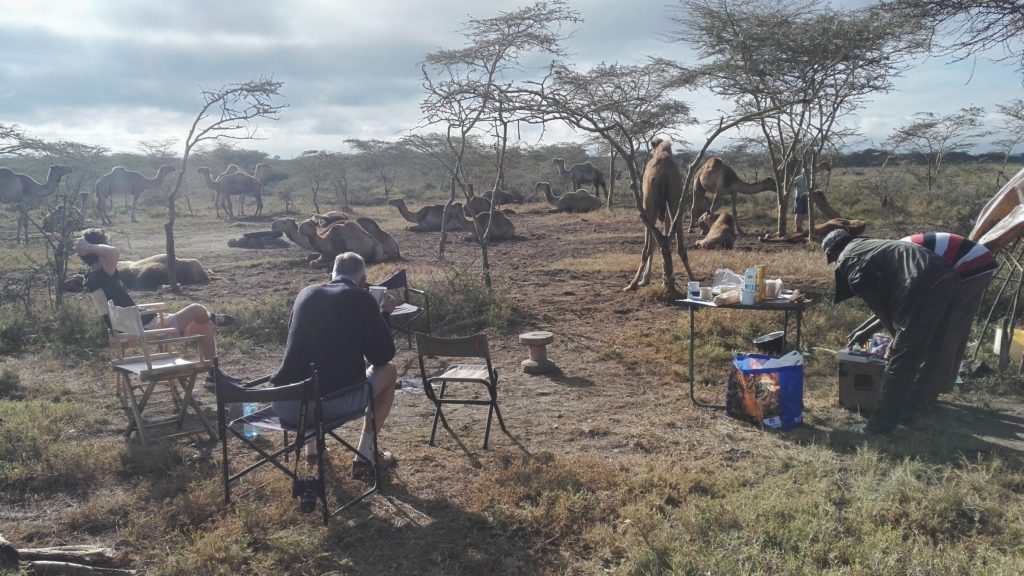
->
[270,252,398,480]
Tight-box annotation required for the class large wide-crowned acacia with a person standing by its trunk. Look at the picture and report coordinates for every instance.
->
[670,0,923,234]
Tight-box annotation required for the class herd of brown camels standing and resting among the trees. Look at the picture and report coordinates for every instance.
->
[0,145,866,289]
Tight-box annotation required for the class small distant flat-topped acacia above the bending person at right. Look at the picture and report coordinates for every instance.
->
[887,107,991,193]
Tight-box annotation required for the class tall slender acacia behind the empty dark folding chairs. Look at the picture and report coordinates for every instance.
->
[420,0,581,280]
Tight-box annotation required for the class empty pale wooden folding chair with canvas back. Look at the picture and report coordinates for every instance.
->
[106,301,217,444]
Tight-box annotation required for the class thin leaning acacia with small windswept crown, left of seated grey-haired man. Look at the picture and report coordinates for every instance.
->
[164,77,286,290]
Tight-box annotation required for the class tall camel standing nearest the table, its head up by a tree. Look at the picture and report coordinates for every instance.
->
[625,138,693,290]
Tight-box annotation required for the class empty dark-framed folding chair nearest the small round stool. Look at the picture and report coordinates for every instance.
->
[416,333,508,450]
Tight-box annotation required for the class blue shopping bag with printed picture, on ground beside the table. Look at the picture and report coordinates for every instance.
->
[725,352,804,430]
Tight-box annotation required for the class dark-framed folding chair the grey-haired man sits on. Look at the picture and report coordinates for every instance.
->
[214,360,380,526]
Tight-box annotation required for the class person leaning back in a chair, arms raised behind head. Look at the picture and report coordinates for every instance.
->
[72,228,234,385]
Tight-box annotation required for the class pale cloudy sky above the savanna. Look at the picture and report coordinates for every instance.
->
[0,0,1022,158]
